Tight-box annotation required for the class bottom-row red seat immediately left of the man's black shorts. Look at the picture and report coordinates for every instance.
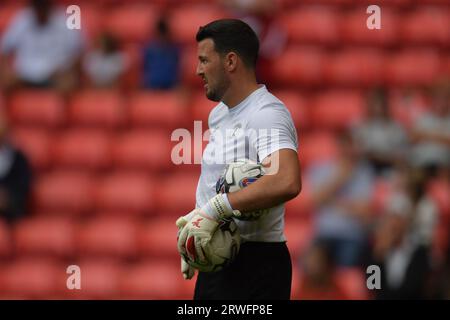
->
[120,260,183,300]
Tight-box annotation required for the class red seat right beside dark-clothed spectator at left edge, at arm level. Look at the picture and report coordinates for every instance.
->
[34,171,95,214]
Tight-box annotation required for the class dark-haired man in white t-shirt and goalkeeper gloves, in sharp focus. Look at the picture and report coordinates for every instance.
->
[177,19,301,299]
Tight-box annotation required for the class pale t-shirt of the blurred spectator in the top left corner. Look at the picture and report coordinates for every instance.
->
[0,8,83,82]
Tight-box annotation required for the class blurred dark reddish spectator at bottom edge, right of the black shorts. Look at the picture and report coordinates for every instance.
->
[299,243,348,300]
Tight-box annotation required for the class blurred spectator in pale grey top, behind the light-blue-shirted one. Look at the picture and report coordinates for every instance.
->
[354,89,407,178]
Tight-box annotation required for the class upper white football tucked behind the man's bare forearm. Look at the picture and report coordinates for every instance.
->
[216,159,268,220]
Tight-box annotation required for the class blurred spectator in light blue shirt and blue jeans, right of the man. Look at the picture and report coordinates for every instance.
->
[306,132,374,267]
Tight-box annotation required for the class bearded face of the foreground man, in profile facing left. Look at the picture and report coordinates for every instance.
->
[197,39,230,102]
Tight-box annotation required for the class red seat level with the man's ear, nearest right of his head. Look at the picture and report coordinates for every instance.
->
[274,46,325,86]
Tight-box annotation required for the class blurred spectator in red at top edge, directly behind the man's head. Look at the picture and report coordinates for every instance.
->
[219,0,287,85]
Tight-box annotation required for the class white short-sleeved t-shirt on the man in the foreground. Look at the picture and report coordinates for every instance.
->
[196,86,298,242]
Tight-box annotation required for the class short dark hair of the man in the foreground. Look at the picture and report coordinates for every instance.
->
[195,19,259,68]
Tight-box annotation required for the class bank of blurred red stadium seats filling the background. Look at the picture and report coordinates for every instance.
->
[0,0,450,299]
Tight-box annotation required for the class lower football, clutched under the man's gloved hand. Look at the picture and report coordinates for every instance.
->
[186,219,241,272]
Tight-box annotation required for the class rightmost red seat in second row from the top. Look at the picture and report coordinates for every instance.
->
[385,49,441,86]
